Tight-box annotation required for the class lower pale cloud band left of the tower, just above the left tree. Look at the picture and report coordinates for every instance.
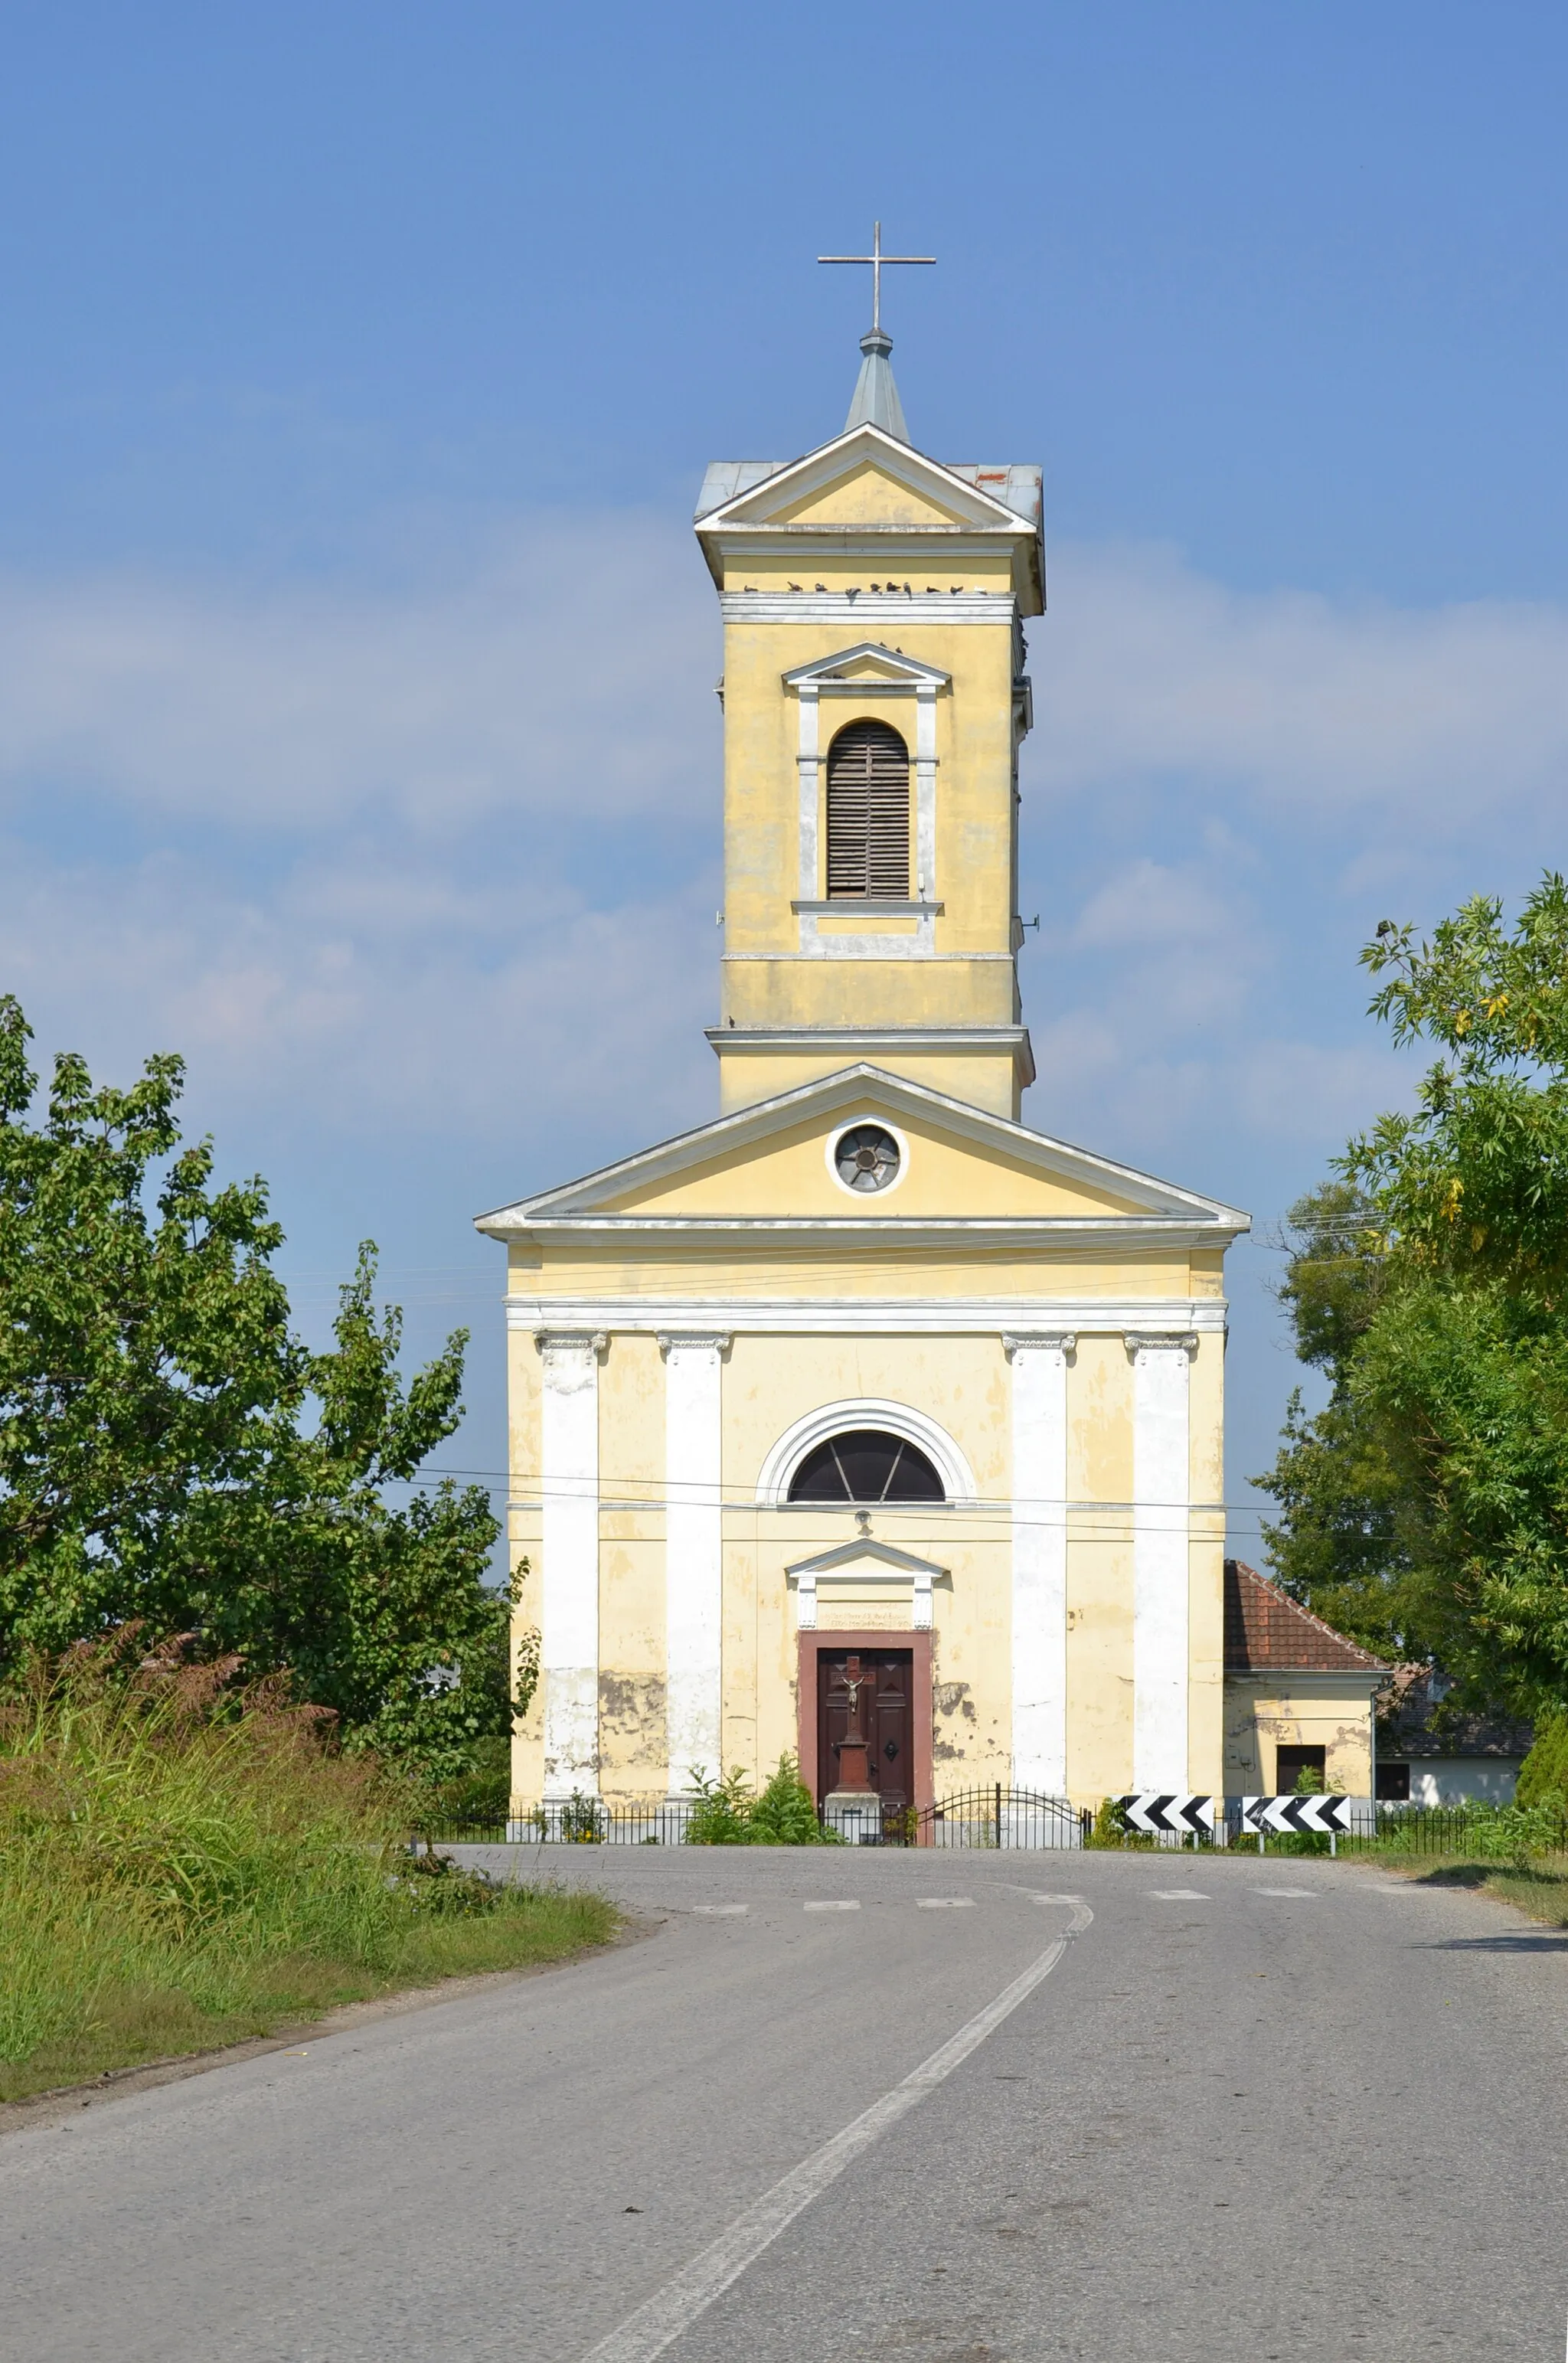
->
[0,842,716,1162]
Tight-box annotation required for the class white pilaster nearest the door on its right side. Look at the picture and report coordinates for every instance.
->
[1001,1330,1076,1796]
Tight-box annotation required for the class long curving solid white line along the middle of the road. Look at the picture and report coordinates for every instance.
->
[581,1904,1093,2363]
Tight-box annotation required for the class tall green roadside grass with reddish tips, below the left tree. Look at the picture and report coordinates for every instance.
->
[0,1645,614,2098]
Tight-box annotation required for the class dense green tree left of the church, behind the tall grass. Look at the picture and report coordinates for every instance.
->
[0,997,527,1777]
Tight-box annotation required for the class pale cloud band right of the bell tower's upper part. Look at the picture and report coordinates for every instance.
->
[1032,546,1568,834]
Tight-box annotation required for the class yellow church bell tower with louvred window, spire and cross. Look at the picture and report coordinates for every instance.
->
[697,239,1044,1120]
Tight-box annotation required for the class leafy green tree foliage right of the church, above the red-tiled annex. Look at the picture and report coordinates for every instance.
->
[1259,874,1568,1711]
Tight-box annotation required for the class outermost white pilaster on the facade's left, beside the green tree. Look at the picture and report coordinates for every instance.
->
[534,1330,607,1798]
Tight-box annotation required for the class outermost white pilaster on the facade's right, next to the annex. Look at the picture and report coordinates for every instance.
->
[1126,1335,1197,1791]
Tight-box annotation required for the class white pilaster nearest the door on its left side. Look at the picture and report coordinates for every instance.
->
[659,1333,730,1796]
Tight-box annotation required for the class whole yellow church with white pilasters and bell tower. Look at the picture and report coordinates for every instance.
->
[479,286,1294,1815]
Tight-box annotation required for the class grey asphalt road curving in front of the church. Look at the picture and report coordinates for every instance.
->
[0,1848,1568,2363]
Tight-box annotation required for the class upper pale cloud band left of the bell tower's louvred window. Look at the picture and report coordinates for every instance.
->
[0,513,718,832]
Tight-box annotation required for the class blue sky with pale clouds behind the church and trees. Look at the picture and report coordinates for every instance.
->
[0,0,1568,1548]
